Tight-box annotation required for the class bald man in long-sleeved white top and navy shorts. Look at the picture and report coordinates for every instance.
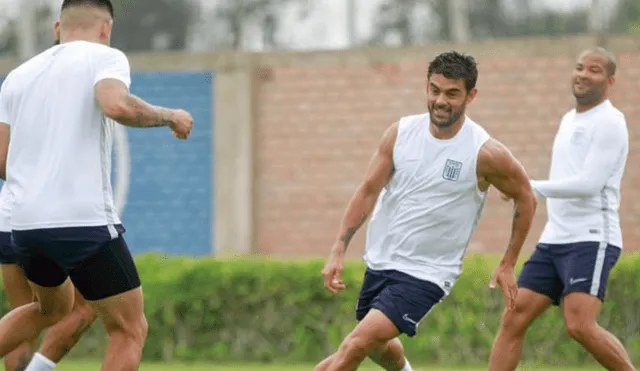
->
[489,48,635,371]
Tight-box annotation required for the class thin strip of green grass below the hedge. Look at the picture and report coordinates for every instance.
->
[56,361,602,371]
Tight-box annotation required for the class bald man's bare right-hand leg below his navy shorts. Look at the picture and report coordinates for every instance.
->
[564,292,636,371]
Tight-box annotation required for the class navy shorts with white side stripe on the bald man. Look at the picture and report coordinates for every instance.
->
[518,242,621,306]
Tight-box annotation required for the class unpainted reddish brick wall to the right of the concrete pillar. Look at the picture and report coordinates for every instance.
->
[255,42,640,257]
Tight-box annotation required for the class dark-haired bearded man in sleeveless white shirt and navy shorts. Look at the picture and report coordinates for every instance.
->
[316,52,536,371]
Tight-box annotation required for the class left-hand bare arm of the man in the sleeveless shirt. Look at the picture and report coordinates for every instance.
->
[322,123,398,293]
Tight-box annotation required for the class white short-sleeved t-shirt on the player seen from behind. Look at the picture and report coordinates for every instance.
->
[0,41,131,234]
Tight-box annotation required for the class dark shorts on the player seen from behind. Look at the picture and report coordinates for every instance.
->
[12,226,140,300]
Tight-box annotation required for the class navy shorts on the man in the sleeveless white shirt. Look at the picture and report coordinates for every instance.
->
[356,268,445,337]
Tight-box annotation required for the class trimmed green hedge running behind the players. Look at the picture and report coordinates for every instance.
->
[0,255,640,365]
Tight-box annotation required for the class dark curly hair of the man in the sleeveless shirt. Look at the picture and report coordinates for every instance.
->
[427,51,478,92]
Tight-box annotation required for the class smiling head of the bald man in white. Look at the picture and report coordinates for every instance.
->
[572,51,614,107]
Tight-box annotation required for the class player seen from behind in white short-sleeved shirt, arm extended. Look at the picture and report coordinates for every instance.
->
[0,0,193,371]
